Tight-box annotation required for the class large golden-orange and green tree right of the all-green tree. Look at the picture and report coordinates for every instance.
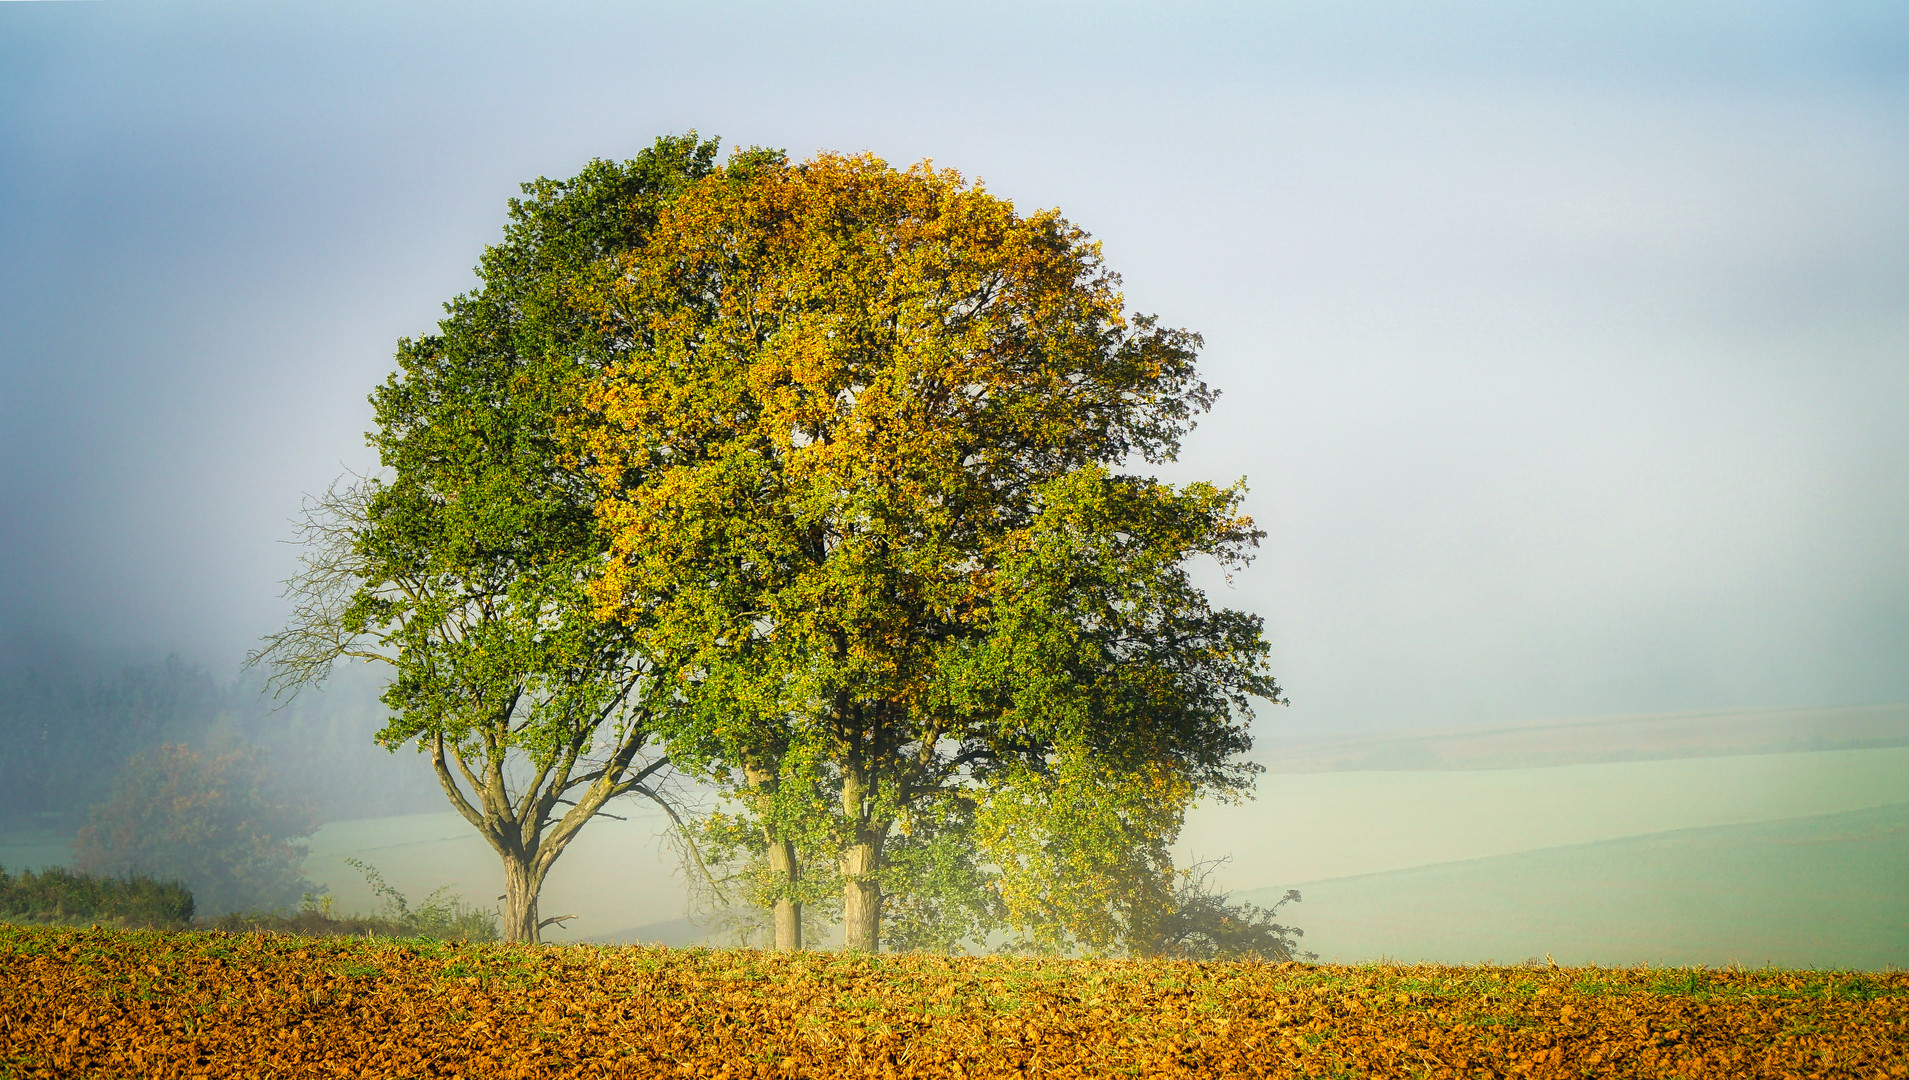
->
[584,155,1279,950]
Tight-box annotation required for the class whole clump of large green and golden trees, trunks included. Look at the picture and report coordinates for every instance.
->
[262,135,1279,950]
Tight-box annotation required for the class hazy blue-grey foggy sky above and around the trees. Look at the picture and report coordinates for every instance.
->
[0,0,1909,735]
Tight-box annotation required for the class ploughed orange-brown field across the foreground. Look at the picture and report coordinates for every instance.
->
[0,927,1909,1078]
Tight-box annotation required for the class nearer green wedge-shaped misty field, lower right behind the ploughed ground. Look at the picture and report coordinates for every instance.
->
[1237,803,1909,971]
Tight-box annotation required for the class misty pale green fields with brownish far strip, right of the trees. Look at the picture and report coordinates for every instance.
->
[1180,706,1909,969]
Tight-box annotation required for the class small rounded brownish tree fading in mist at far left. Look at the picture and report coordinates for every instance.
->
[73,744,319,916]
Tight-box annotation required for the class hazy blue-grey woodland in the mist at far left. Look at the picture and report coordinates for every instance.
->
[0,649,437,925]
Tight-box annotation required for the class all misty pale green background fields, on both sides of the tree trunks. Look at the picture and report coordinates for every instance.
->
[0,706,1909,967]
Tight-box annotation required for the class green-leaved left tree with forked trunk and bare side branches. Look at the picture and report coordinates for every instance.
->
[254,134,716,941]
